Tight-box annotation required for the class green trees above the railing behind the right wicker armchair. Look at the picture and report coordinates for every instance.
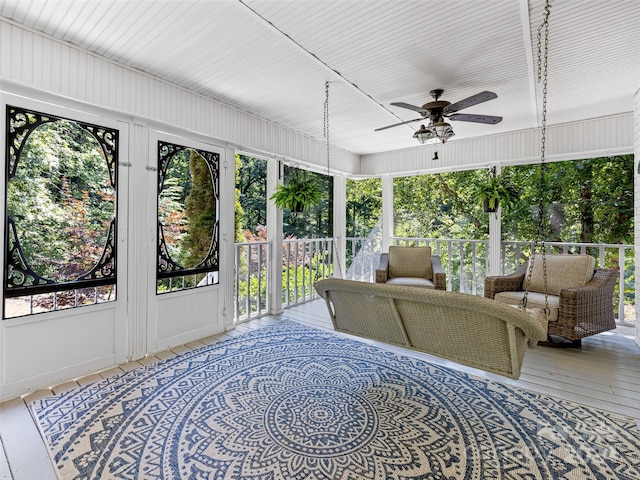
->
[502,155,634,244]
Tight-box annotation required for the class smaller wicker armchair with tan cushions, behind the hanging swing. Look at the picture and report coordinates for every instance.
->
[376,246,447,290]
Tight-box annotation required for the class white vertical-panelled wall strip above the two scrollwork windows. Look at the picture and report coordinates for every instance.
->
[0,20,359,173]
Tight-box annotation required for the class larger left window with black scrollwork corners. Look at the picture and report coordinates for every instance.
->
[4,105,118,318]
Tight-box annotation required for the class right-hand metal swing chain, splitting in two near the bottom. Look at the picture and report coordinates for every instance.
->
[519,0,551,315]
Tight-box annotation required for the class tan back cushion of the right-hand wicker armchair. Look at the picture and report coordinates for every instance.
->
[524,254,596,295]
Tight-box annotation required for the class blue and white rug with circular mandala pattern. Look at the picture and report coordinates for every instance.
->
[32,323,640,480]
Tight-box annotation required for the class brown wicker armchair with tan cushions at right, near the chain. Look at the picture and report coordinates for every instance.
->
[484,255,618,346]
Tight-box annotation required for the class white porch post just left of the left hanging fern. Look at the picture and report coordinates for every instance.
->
[265,160,284,315]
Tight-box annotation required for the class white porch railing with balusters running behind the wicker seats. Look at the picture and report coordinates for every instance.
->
[235,237,635,325]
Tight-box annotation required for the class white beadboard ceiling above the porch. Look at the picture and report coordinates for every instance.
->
[0,0,640,154]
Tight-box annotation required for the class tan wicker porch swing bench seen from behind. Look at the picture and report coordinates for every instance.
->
[316,278,547,378]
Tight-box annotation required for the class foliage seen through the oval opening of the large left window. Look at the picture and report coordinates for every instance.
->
[7,120,115,282]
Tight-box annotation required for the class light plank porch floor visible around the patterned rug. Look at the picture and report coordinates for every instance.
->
[0,300,640,480]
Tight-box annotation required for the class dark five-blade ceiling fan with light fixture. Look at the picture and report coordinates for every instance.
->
[375,89,502,143]
